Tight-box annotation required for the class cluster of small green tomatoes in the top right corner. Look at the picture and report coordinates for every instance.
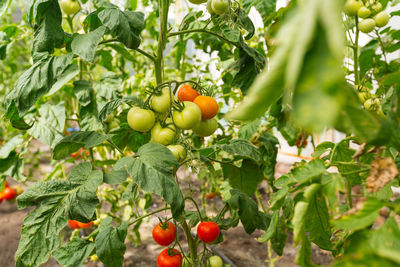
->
[344,0,390,33]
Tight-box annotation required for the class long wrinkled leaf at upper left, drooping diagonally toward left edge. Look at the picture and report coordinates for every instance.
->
[4,54,73,119]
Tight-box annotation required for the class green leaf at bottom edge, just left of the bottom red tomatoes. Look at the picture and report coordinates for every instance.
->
[95,218,128,267]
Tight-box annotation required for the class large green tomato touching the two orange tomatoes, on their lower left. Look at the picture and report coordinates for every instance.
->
[172,101,201,130]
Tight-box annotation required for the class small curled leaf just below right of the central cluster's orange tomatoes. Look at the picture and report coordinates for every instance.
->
[220,139,262,165]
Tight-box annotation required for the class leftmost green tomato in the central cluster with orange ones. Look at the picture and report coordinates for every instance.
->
[127,107,156,133]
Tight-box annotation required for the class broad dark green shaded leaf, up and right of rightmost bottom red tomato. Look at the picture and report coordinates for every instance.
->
[222,159,264,196]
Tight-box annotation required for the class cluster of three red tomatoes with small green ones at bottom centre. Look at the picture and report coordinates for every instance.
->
[152,221,223,267]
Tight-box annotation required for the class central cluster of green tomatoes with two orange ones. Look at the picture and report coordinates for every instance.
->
[127,85,219,161]
